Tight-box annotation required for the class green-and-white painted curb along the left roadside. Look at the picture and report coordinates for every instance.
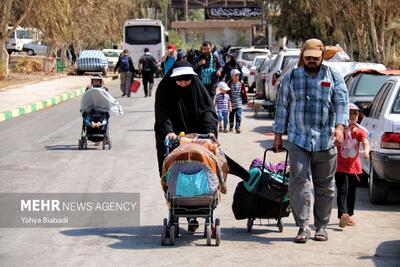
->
[0,77,113,122]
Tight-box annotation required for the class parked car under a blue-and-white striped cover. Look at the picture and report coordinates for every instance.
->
[76,50,108,75]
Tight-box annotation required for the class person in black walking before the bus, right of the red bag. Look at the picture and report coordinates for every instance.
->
[139,47,157,97]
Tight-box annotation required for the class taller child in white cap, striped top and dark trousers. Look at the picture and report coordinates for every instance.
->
[229,69,244,134]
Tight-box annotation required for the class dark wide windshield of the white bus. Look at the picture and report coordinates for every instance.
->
[125,25,161,45]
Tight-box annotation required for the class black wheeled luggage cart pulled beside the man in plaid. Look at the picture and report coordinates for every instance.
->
[232,148,290,232]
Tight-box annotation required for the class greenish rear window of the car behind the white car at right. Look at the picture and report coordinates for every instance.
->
[354,73,390,96]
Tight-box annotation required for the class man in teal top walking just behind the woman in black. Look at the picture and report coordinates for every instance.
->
[193,41,221,101]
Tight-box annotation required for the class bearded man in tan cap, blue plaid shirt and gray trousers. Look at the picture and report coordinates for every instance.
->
[274,39,349,243]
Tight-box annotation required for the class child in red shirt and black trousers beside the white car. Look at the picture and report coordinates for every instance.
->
[335,103,369,228]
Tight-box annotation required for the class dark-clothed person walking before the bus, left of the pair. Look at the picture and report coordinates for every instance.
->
[114,49,135,97]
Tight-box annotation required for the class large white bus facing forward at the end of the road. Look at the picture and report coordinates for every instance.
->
[123,19,167,69]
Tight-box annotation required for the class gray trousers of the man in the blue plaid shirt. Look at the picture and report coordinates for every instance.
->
[288,143,337,228]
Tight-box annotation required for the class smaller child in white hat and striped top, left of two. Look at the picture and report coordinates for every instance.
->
[215,82,232,133]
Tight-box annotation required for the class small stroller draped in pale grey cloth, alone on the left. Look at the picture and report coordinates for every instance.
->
[78,87,123,150]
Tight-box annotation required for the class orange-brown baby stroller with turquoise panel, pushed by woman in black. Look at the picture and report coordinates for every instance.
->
[161,134,227,246]
